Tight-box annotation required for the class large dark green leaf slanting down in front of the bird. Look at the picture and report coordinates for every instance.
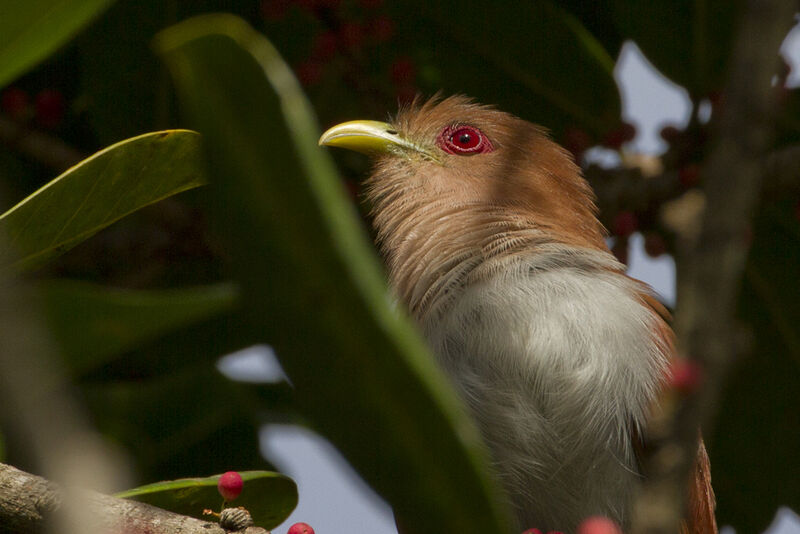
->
[157,16,508,534]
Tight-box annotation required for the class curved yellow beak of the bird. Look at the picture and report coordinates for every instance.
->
[319,121,433,158]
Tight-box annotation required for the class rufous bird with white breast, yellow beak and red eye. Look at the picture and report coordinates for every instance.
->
[319,95,716,534]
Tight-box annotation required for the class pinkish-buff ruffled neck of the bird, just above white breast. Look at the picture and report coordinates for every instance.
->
[375,200,598,318]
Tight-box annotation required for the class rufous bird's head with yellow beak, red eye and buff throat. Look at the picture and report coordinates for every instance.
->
[320,96,605,311]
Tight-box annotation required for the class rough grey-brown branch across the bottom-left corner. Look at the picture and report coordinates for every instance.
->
[0,464,267,534]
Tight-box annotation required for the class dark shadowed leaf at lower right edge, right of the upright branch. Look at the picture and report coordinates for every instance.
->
[709,199,800,532]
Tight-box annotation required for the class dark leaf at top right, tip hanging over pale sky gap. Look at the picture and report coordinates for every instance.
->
[611,0,744,98]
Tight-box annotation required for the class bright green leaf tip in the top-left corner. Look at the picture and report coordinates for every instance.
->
[0,0,113,87]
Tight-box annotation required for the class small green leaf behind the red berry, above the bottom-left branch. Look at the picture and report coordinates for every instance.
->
[116,471,297,529]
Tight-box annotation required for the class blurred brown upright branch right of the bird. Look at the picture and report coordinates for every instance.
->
[632,0,797,534]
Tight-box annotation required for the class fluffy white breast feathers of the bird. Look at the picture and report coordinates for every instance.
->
[419,245,669,532]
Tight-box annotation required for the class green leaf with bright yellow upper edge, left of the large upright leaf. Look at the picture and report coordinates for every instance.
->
[0,130,205,269]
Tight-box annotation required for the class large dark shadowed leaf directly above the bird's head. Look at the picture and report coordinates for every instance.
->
[393,0,621,136]
